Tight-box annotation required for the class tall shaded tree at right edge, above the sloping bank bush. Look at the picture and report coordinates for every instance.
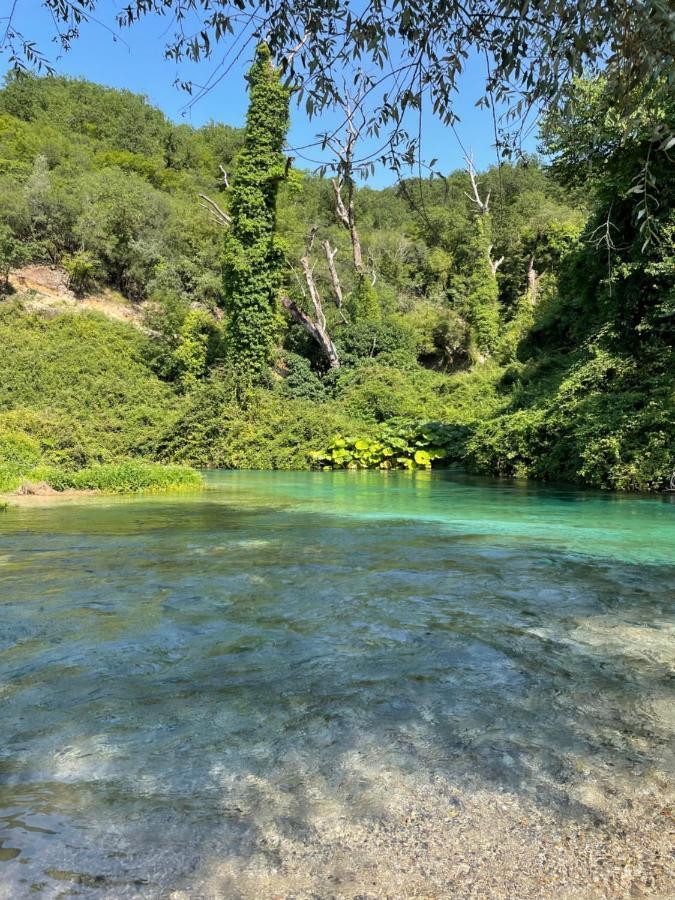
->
[542,79,675,346]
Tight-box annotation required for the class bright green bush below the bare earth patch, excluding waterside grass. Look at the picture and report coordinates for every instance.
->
[0,303,179,468]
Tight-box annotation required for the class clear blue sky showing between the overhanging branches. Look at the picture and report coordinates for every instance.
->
[0,0,535,187]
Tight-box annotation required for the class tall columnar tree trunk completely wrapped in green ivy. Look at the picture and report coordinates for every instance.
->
[224,44,290,381]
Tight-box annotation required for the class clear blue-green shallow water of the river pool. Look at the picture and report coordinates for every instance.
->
[0,472,675,897]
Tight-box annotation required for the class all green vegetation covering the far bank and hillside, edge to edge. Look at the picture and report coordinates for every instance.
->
[0,72,675,490]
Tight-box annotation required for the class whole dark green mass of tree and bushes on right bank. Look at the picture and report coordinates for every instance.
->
[467,82,675,490]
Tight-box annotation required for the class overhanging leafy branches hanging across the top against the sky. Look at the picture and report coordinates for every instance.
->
[7,0,675,169]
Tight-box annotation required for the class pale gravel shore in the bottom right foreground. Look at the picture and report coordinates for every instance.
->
[171,748,675,900]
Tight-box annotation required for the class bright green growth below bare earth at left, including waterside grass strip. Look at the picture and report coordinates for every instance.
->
[0,303,201,493]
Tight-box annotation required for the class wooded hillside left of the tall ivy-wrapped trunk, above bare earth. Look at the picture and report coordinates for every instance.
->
[0,72,242,304]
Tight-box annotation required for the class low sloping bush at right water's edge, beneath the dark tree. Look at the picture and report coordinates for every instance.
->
[466,345,675,491]
